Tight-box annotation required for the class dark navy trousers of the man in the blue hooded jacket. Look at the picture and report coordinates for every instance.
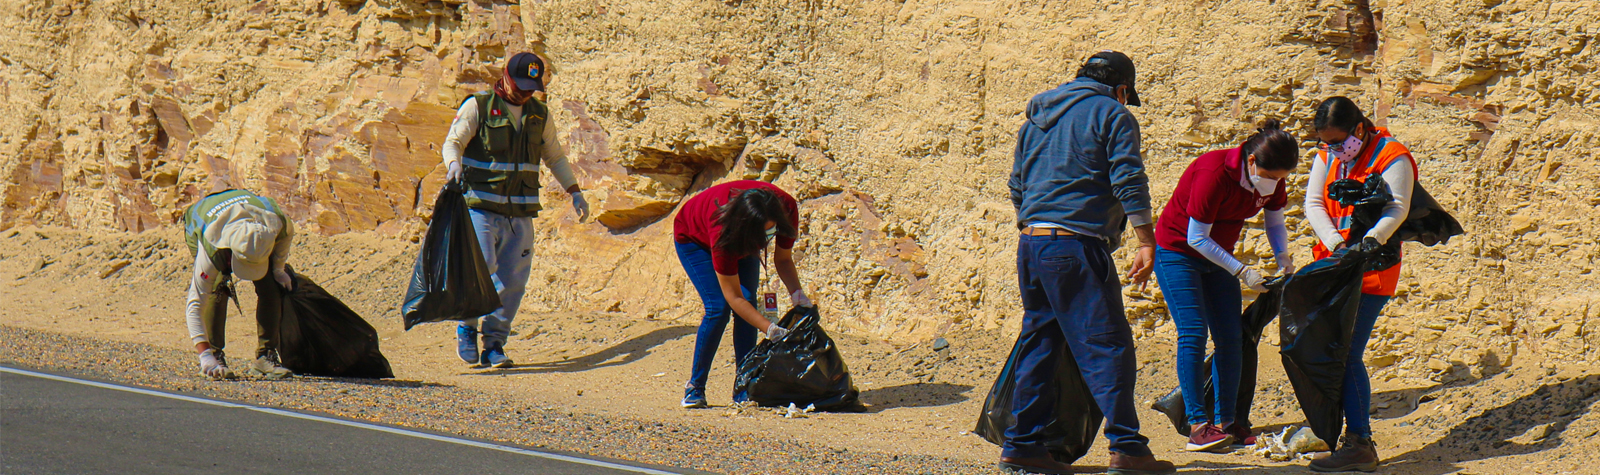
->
[1000,235,1150,457]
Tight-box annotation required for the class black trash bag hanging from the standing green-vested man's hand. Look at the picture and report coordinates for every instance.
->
[400,182,501,329]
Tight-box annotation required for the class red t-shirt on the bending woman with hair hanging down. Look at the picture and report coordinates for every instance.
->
[672,179,800,275]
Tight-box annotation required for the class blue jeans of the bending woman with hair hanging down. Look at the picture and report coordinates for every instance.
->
[677,243,762,389]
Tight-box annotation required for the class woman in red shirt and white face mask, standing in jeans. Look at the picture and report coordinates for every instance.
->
[1155,120,1299,451]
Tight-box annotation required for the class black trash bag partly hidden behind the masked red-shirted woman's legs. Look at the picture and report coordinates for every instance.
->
[1150,277,1288,437]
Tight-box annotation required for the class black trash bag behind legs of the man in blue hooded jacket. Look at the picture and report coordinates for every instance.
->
[973,331,1107,464]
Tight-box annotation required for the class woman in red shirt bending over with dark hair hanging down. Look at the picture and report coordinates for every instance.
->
[672,181,811,408]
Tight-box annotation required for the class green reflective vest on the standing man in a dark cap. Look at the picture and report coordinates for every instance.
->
[461,91,550,218]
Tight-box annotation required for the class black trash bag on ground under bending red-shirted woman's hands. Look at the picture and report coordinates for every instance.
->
[733,307,864,411]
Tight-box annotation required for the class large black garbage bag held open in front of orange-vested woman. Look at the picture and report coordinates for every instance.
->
[1278,249,1373,440]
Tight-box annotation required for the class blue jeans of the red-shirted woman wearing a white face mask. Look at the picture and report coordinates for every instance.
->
[1155,248,1248,427]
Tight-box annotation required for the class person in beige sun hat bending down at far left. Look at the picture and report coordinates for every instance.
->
[184,190,294,379]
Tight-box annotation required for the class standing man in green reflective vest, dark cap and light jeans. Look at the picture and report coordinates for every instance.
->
[443,53,589,368]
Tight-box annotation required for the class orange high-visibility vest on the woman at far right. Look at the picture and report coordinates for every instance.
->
[1312,126,1418,296]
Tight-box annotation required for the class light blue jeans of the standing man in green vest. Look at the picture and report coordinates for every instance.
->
[461,210,533,349]
